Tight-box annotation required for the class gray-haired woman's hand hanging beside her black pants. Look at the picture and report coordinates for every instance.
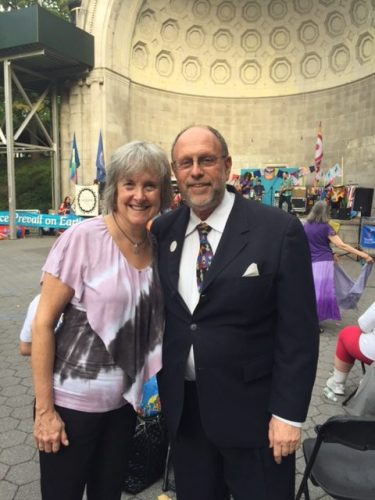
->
[34,409,69,453]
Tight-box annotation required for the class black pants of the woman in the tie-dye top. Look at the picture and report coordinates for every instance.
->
[39,404,136,500]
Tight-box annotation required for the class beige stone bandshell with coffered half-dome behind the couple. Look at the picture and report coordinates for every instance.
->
[62,0,375,199]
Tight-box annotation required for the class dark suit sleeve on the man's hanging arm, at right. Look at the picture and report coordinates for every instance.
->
[270,219,319,422]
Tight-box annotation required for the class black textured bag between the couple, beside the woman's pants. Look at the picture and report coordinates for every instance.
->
[123,413,168,495]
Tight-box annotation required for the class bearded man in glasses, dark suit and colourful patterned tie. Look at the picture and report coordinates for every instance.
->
[152,126,319,500]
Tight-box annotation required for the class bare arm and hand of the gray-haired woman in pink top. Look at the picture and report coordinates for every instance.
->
[31,273,74,453]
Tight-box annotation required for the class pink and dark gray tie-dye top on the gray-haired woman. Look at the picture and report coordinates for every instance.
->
[43,216,164,412]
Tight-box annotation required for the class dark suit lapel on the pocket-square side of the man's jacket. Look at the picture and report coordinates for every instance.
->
[202,195,250,292]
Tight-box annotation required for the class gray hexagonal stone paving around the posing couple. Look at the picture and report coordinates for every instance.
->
[0,236,375,500]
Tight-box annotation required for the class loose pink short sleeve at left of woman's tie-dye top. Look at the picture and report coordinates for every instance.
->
[42,225,89,301]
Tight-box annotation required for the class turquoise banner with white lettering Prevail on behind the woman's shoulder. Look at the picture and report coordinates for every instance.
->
[0,211,85,229]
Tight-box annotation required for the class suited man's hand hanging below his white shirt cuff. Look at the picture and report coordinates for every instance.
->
[268,417,301,464]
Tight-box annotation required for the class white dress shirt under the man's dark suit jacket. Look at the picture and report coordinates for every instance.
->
[178,191,301,427]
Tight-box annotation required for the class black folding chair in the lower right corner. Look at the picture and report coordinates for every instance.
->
[295,415,375,500]
